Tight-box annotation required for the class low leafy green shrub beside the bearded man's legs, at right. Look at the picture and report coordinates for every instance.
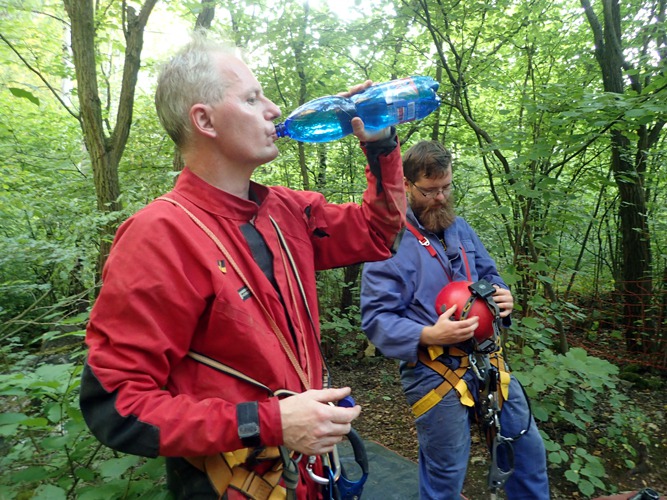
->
[514,332,650,497]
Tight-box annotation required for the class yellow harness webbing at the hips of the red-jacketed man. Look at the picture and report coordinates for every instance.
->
[185,447,287,500]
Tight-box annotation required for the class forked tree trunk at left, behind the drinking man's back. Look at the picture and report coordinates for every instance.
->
[64,0,157,273]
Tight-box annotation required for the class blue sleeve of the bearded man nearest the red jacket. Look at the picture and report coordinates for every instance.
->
[361,256,423,362]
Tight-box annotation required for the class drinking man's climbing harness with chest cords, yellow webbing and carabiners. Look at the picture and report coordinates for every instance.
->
[158,196,368,500]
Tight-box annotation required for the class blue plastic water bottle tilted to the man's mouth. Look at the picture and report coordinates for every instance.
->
[276,76,440,142]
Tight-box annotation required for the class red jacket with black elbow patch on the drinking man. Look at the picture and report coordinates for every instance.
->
[81,144,405,497]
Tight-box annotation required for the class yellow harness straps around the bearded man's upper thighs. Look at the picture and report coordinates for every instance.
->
[412,346,510,417]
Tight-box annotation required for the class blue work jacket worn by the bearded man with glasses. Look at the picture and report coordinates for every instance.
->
[361,208,509,363]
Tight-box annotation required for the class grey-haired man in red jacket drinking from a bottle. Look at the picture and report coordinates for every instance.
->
[81,33,405,499]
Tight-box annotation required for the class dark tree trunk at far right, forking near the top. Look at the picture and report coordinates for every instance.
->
[581,0,667,350]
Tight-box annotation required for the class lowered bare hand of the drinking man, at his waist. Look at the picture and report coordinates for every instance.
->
[280,387,361,455]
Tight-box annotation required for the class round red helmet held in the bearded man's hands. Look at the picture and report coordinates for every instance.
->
[435,281,495,343]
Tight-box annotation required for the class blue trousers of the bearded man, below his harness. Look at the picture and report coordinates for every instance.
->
[401,363,549,500]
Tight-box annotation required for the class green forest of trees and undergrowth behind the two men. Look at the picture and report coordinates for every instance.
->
[0,0,667,499]
